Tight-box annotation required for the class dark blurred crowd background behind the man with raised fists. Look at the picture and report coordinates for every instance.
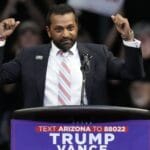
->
[0,0,150,150]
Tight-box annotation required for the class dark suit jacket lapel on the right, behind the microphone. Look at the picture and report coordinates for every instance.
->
[77,43,95,103]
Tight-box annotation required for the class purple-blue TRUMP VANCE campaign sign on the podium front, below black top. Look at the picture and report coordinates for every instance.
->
[11,119,150,150]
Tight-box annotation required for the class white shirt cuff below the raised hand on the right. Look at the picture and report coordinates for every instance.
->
[123,39,141,48]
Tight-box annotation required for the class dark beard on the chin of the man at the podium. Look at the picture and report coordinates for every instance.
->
[53,39,76,52]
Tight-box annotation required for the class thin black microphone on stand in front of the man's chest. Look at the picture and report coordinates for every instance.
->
[80,53,93,105]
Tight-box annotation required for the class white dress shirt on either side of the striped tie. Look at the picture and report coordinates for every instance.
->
[44,42,87,106]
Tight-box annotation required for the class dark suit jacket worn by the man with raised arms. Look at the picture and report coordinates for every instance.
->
[0,43,144,107]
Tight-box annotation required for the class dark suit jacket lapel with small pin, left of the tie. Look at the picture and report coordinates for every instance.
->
[35,44,51,106]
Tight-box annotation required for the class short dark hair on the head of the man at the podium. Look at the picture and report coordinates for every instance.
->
[46,4,78,26]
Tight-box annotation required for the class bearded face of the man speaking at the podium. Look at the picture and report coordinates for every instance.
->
[47,13,78,52]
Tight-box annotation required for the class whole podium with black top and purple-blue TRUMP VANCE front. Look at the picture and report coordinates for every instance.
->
[11,106,150,150]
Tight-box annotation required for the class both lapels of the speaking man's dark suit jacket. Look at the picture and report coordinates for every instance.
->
[34,43,95,106]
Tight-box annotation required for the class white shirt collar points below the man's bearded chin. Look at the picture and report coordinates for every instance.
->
[51,41,77,56]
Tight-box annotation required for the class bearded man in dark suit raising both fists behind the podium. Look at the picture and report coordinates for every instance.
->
[0,4,143,107]
